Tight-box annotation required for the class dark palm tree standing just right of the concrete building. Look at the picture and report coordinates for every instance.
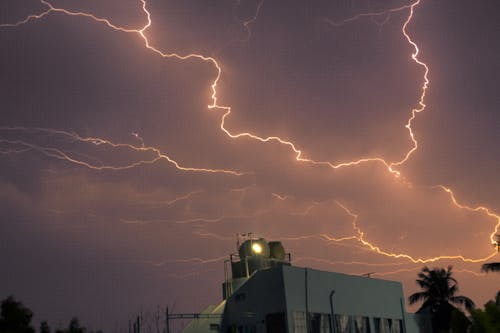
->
[408,266,474,332]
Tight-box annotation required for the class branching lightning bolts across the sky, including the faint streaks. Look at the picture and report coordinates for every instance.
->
[0,0,500,270]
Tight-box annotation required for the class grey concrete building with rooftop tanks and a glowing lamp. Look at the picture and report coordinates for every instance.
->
[182,239,432,333]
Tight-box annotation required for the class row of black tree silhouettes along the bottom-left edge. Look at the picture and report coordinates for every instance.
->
[0,296,102,333]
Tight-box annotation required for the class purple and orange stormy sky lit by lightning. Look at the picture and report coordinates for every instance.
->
[0,0,500,331]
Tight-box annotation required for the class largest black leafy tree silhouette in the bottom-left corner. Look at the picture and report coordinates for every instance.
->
[0,296,35,333]
